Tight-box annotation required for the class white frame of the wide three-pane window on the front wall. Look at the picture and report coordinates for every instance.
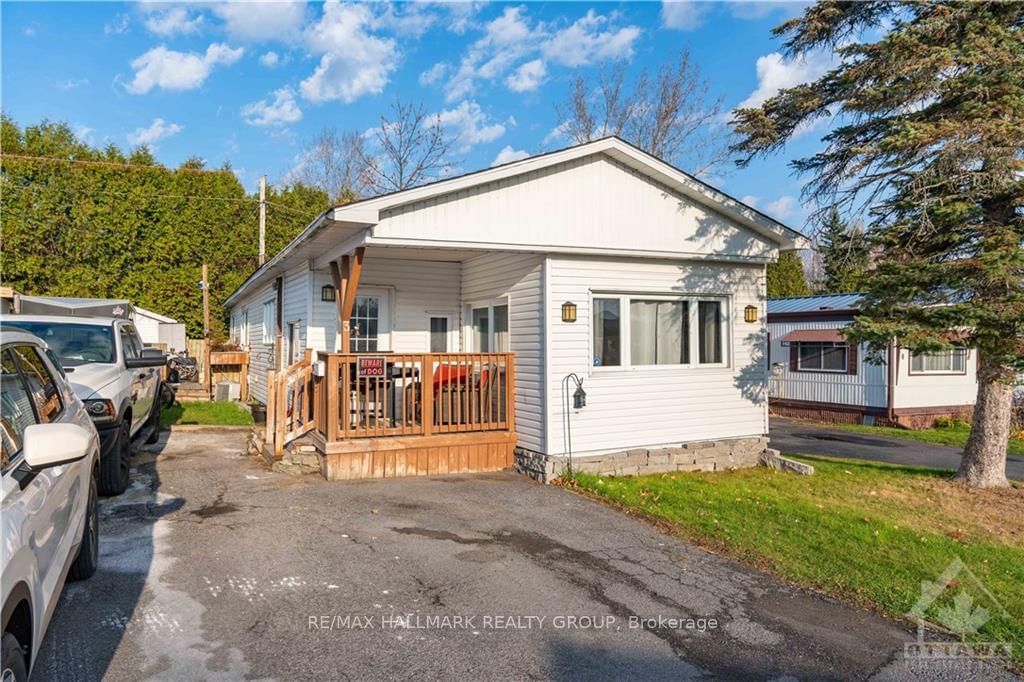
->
[589,290,732,374]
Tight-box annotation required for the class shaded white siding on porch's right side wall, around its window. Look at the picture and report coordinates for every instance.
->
[462,249,545,452]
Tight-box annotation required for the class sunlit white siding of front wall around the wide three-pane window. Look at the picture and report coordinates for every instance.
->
[547,258,768,455]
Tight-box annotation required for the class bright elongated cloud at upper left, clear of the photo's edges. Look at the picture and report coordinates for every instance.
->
[126,43,244,94]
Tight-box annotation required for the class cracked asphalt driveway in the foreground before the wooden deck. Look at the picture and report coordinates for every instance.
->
[35,432,1009,680]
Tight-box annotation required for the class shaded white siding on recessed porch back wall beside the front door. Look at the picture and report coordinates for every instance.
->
[309,253,461,353]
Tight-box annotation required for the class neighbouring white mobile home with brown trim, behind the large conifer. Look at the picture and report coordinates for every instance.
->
[768,294,978,428]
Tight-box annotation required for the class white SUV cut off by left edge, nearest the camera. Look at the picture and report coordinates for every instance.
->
[0,328,99,682]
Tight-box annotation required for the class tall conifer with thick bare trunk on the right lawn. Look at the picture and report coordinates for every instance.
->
[733,0,1024,487]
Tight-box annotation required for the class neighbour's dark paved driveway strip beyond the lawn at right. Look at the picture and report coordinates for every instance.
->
[770,417,1024,480]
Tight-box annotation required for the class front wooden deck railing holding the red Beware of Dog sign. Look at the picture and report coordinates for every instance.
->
[312,353,515,442]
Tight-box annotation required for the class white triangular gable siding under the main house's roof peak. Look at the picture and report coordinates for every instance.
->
[374,156,776,257]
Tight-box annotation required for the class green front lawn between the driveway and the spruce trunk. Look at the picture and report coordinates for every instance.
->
[567,457,1024,667]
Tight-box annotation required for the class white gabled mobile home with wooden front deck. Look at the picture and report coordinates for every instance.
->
[226,137,804,479]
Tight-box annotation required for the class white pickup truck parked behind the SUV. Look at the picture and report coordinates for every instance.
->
[3,314,167,495]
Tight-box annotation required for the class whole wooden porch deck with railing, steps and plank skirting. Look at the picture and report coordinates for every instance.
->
[267,353,516,480]
